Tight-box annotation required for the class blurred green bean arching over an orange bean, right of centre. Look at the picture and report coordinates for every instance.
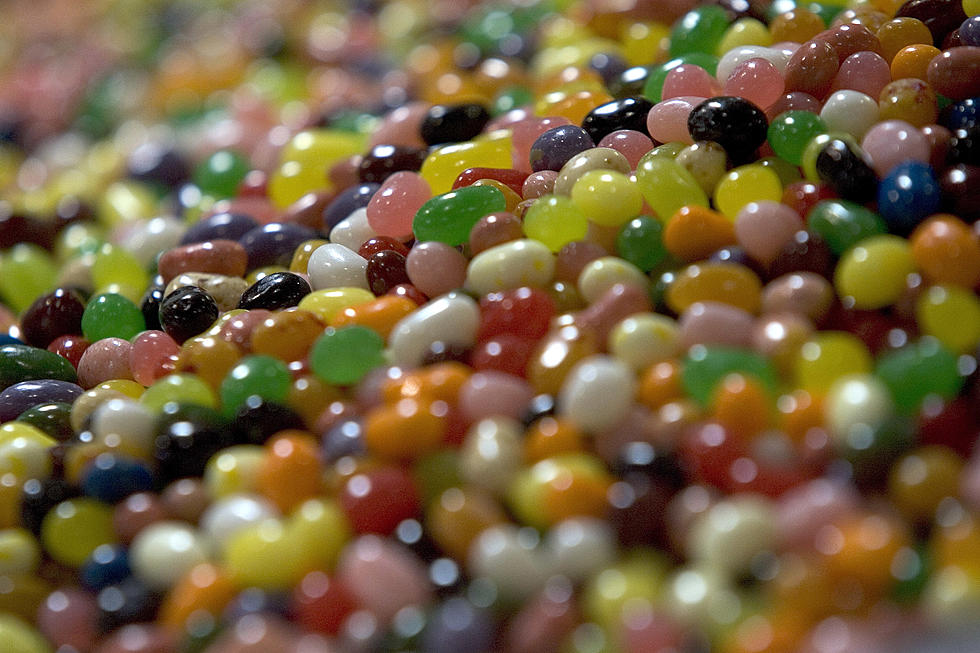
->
[681,345,778,406]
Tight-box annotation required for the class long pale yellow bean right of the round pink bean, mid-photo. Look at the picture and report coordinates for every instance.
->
[466,239,555,295]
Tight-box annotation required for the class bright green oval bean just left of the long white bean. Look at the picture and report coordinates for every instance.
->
[310,325,385,385]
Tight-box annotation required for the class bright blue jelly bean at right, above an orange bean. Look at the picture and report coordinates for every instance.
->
[878,161,941,236]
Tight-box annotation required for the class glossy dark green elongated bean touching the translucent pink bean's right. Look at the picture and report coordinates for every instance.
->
[412,186,507,247]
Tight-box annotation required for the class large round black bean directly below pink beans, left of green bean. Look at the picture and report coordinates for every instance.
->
[687,95,769,164]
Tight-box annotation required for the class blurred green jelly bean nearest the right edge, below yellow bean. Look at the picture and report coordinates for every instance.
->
[875,336,966,412]
